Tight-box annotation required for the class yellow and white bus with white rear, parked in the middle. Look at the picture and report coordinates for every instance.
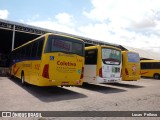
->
[84,45,122,84]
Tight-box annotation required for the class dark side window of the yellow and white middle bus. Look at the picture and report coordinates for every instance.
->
[85,50,97,65]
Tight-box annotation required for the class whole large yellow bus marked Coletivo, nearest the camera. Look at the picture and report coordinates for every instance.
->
[10,33,85,86]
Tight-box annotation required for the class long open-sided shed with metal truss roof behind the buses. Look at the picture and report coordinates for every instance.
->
[0,19,160,67]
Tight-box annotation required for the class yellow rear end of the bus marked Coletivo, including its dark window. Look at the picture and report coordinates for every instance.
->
[42,35,84,86]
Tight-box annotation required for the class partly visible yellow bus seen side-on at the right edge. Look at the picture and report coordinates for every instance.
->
[140,60,160,79]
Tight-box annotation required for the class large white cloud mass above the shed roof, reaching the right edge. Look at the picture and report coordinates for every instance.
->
[22,0,160,52]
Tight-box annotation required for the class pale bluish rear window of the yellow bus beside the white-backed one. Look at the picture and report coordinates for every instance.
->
[127,52,140,63]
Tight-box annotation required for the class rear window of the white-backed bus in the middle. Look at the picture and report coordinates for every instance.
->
[102,48,121,65]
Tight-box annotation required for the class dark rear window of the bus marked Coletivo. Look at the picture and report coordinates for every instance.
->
[45,36,84,56]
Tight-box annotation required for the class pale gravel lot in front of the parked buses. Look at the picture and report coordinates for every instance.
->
[0,77,160,120]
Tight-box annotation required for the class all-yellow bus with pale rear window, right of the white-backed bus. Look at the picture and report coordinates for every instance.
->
[122,51,141,81]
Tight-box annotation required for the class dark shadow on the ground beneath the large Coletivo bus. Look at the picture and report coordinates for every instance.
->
[9,78,87,102]
